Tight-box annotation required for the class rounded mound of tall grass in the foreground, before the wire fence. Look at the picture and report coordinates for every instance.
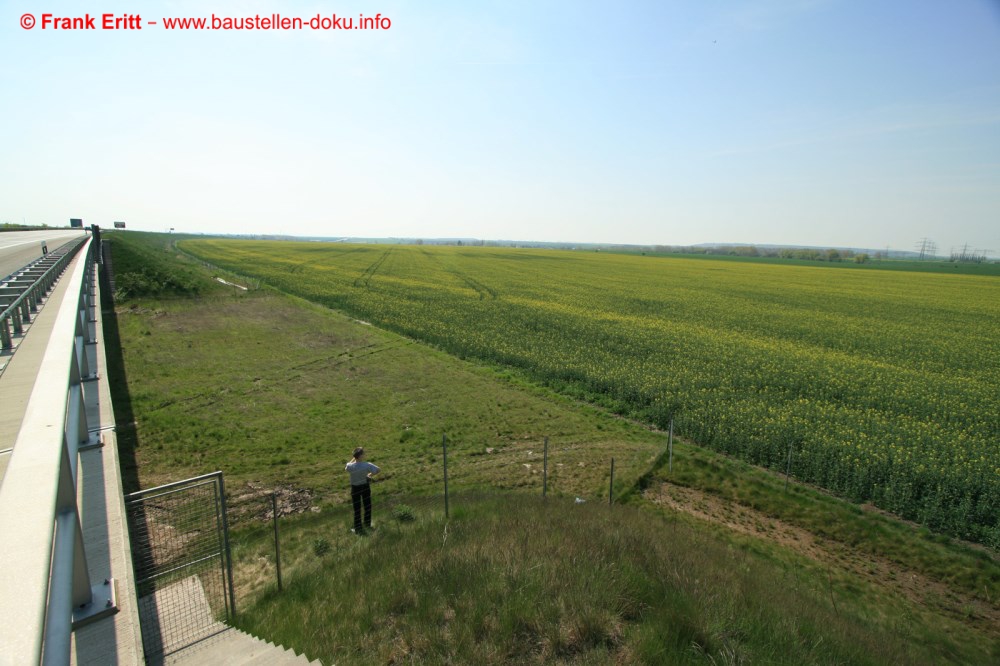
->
[230,495,996,664]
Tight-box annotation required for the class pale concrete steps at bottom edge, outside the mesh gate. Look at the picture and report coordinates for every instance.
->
[161,627,322,666]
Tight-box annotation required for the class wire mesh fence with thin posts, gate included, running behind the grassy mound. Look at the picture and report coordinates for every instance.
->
[126,428,668,644]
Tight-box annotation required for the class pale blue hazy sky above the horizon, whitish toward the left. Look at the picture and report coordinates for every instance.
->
[0,0,1000,255]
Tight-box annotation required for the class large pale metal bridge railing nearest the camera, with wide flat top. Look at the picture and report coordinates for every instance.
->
[0,238,116,664]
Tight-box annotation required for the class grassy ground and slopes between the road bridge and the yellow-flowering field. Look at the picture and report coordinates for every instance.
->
[105,234,1000,663]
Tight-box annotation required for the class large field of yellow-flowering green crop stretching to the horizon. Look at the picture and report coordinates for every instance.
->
[181,240,1000,547]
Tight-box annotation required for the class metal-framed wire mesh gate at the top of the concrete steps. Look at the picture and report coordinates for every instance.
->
[125,472,235,663]
